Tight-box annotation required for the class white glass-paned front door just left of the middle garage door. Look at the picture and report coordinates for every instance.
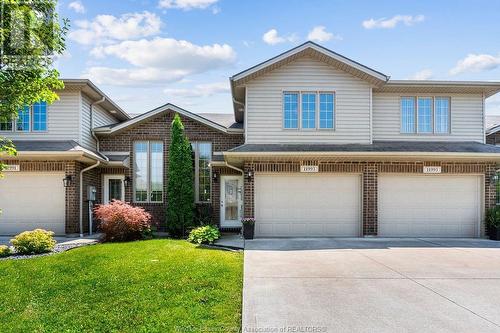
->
[220,176,243,228]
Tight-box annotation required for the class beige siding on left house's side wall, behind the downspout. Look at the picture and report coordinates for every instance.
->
[80,94,118,149]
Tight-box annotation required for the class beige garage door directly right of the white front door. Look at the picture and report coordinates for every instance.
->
[255,174,361,237]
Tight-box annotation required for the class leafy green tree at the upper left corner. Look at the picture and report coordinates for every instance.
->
[0,0,69,173]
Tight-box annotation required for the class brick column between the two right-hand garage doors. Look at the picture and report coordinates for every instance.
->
[363,164,378,236]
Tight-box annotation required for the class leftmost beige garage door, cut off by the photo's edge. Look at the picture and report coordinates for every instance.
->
[0,172,65,235]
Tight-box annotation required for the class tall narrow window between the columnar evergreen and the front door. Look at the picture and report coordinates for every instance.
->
[191,142,212,202]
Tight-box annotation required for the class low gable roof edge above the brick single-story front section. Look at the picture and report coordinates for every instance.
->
[94,103,243,135]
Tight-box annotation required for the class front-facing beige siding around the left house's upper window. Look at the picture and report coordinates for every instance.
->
[0,91,80,141]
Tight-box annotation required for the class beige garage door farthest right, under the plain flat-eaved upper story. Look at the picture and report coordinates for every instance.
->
[378,175,482,237]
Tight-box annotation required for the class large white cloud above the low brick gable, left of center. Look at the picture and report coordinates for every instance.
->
[87,37,236,85]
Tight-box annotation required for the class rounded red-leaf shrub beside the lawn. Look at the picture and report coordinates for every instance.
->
[94,200,151,242]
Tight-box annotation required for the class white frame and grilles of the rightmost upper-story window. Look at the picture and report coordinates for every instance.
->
[399,95,452,136]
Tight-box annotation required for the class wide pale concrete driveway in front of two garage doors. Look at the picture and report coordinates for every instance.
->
[243,239,500,333]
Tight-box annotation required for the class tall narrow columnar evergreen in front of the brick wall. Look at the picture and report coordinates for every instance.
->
[167,114,194,237]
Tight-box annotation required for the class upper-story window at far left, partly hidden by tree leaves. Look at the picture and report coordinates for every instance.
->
[0,102,47,132]
